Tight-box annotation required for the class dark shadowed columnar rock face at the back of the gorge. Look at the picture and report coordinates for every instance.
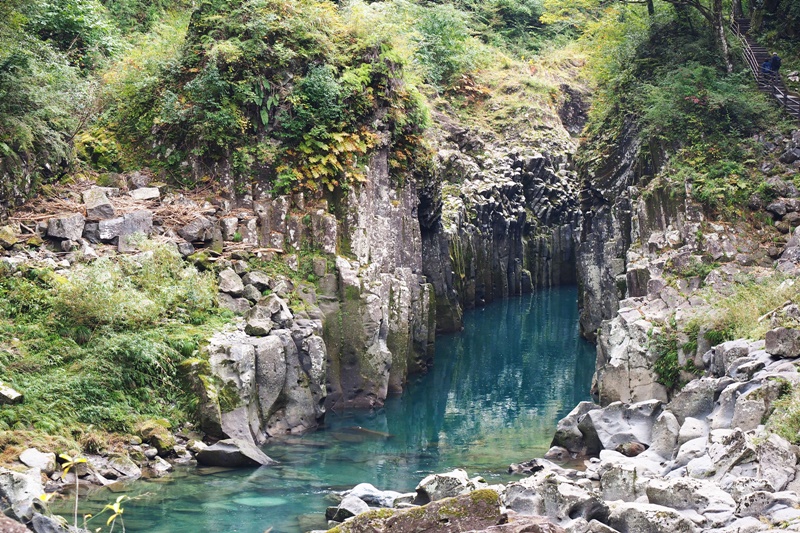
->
[420,117,581,331]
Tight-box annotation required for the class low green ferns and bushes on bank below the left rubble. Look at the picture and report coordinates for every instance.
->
[0,243,229,449]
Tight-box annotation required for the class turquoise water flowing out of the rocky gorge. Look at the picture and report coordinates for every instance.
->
[57,288,594,533]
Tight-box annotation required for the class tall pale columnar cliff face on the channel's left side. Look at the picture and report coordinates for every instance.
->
[320,149,435,407]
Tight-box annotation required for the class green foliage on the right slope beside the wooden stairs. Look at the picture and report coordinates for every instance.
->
[572,2,789,214]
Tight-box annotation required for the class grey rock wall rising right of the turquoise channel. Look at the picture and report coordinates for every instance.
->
[578,127,800,405]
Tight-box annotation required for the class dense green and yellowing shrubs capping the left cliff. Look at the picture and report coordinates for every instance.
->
[107,0,426,191]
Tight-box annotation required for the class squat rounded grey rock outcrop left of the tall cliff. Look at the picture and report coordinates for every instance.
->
[192,315,326,444]
